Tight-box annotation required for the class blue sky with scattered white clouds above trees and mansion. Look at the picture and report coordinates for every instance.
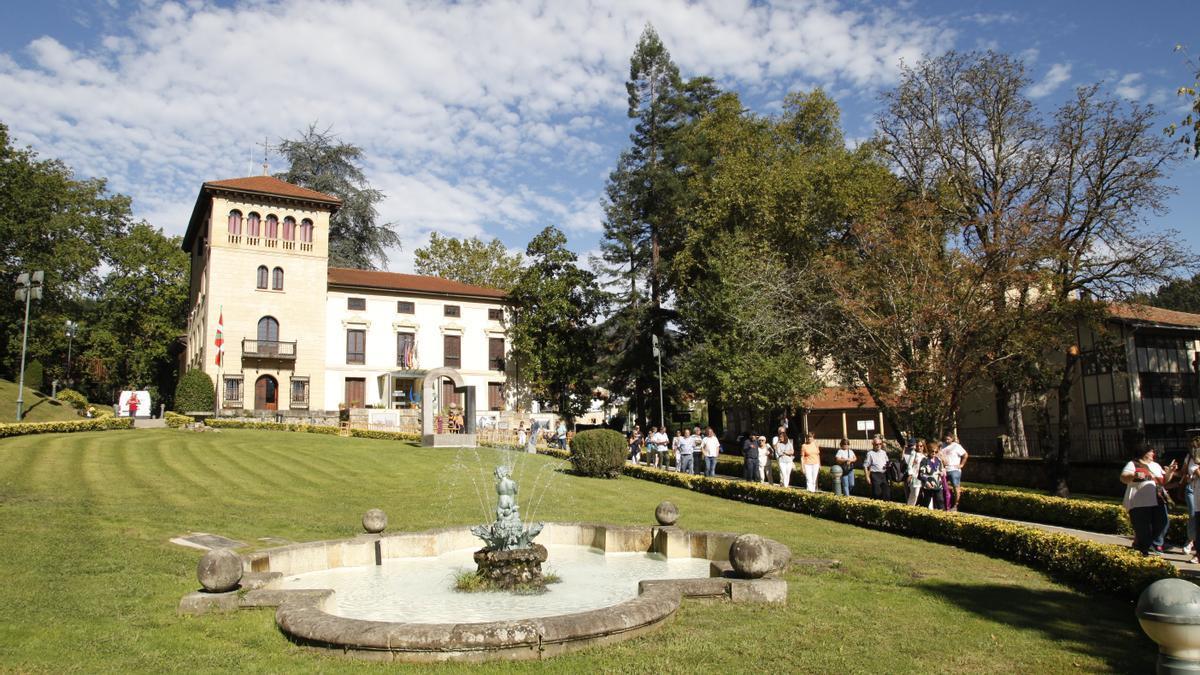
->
[0,0,1200,271]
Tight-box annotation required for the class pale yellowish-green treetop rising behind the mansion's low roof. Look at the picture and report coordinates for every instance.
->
[414,232,521,291]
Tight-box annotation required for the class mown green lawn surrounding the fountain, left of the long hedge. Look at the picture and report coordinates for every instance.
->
[0,430,1156,673]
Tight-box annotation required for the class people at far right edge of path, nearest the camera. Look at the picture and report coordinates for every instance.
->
[1121,437,1200,563]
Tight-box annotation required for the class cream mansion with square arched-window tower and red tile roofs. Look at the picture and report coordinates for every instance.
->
[182,175,508,416]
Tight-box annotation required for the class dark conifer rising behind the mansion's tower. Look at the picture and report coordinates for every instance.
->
[275,124,400,269]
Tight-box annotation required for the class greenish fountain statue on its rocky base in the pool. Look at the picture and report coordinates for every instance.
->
[470,465,547,591]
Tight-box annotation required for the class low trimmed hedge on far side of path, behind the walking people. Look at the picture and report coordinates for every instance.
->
[716,456,1188,544]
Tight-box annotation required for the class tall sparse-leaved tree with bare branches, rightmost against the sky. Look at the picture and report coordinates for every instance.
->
[877,52,1188,494]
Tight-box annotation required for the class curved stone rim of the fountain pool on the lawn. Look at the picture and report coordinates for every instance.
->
[202,522,787,662]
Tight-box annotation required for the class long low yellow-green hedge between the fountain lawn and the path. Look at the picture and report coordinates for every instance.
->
[545,450,1178,599]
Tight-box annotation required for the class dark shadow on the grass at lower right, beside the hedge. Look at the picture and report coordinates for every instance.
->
[916,581,1158,673]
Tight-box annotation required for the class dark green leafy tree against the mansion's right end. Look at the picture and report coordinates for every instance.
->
[509,227,602,419]
